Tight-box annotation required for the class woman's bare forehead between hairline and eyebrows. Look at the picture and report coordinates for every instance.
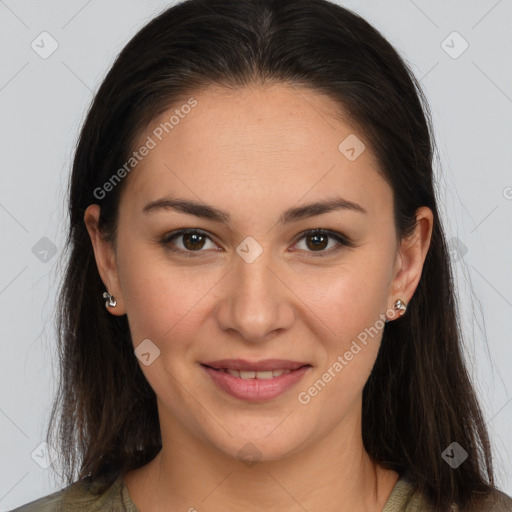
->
[123,84,391,218]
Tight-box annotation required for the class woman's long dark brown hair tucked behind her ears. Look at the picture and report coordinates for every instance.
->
[48,0,494,511]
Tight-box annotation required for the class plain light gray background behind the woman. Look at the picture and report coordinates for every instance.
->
[0,0,512,511]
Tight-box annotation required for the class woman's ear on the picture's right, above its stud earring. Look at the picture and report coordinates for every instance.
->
[388,206,434,318]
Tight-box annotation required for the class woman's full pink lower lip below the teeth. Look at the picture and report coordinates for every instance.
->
[201,365,311,402]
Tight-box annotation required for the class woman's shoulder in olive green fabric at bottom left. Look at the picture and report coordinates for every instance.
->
[11,477,138,512]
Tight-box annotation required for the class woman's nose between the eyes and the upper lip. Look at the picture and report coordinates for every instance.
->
[216,244,294,343]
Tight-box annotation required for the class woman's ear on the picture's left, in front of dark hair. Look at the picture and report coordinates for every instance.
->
[84,204,126,316]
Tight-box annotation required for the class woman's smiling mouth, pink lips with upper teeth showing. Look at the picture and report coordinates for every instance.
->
[201,359,312,402]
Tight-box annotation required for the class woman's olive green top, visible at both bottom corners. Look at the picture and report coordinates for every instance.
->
[11,475,512,512]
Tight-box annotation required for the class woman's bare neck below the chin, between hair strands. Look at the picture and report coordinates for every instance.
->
[125,406,398,512]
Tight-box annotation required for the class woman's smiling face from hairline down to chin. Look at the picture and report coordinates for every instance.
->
[86,84,428,460]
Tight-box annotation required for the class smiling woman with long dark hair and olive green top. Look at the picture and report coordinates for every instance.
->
[12,0,512,512]
